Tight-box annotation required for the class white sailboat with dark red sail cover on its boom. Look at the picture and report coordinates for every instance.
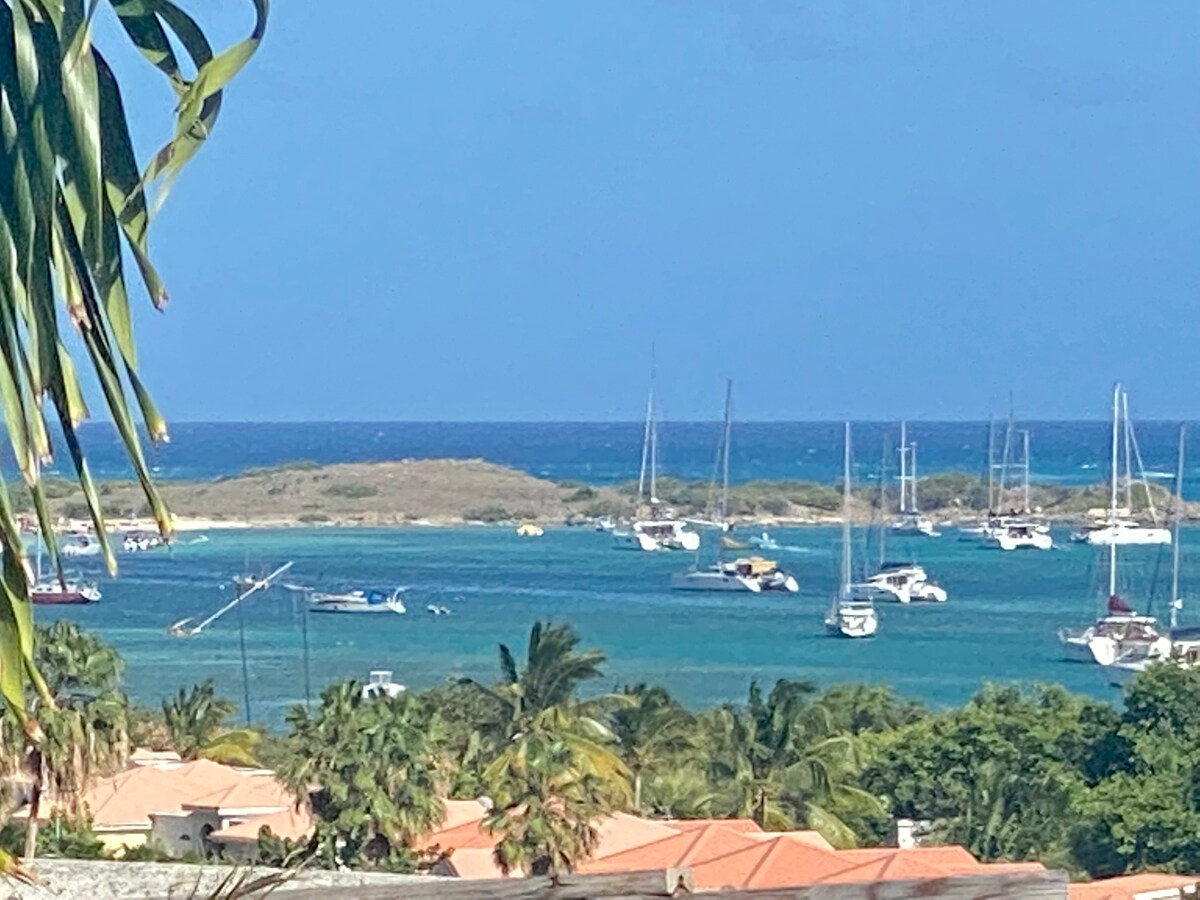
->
[1058,383,1170,666]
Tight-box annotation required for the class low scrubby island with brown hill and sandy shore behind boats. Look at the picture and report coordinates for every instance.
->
[14,460,1200,526]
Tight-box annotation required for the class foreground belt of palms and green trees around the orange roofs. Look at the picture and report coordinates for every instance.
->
[11,623,1200,877]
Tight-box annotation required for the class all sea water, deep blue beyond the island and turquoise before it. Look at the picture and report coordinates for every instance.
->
[37,422,1200,725]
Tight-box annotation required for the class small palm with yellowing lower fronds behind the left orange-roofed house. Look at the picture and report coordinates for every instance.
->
[162,678,263,766]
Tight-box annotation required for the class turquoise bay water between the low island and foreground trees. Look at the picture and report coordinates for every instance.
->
[37,528,1200,724]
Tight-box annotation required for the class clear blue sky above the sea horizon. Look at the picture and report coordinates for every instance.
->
[98,0,1200,420]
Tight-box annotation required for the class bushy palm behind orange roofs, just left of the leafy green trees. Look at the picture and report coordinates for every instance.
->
[704,679,878,846]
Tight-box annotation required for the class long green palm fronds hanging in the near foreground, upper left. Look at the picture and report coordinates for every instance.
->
[0,0,268,870]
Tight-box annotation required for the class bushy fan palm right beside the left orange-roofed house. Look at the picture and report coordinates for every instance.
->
[280,682,445,864]
